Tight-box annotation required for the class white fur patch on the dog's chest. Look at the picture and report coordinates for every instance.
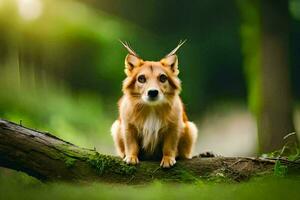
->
[141,112,162,152]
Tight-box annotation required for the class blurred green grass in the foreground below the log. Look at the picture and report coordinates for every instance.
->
[0,169,300,200]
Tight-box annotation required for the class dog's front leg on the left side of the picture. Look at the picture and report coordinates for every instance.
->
[123,124,139,165]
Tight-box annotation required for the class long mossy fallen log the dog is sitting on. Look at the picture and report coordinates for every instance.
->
[0,119,296,184]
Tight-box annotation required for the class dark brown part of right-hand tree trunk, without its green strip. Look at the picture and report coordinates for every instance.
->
[258,0,298,152]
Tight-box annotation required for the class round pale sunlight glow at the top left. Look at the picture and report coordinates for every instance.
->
[17,0,43,21]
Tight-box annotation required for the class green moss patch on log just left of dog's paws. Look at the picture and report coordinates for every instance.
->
[87,152,136,175]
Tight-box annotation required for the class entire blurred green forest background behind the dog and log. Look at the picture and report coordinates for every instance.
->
[0,0,300,156]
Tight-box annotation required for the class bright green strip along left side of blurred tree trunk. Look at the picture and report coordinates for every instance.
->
[236,0,262,117]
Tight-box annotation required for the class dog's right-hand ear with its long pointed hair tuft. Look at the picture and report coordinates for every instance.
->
[160,40,186,75]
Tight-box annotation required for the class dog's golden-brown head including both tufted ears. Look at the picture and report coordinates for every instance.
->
[123,42,184,106]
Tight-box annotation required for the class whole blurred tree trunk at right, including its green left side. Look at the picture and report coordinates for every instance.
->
[237,0,298,153]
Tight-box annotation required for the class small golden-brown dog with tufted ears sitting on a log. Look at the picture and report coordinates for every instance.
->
[111,42,197,168]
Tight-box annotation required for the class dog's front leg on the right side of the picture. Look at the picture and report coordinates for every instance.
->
[160,126,178,168]
